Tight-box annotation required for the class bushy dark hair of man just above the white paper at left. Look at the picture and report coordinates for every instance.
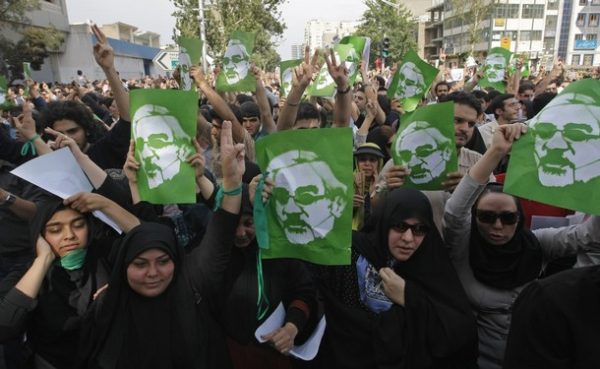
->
[40,100,104,143]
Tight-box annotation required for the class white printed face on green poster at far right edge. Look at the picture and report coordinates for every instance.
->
[530,93,600,187]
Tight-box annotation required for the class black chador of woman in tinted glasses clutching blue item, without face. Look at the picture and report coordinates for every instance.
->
[328,188,477,368]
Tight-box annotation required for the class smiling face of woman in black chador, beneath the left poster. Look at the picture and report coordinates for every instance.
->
[127,249,175,297]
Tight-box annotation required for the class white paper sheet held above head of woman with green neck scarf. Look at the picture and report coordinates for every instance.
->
[11,147,123,233]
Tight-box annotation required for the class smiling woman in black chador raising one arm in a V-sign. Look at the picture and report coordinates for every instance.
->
[80,122,244,369]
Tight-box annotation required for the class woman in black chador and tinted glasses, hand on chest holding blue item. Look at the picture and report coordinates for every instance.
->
[319,188,477,369]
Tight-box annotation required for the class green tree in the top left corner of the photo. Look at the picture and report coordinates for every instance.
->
[0,0,64,79]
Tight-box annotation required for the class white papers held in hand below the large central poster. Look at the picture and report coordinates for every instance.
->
[254,302,327,361]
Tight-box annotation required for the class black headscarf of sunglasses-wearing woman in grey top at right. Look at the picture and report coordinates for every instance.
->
[469,183,543,290]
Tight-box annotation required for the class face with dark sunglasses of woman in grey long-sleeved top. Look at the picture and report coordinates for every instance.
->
[475,192,518,246]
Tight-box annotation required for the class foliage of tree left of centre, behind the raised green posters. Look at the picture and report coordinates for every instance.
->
[172,0,285,70]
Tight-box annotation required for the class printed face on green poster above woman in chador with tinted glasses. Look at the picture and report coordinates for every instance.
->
[396,122,452,184]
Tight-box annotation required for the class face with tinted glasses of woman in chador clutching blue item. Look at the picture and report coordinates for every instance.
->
[388,218,427,261]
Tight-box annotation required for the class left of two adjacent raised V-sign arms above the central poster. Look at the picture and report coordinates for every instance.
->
[277,46,319,131]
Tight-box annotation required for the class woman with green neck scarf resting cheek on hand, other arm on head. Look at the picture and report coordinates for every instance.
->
[0,193,139,368]
